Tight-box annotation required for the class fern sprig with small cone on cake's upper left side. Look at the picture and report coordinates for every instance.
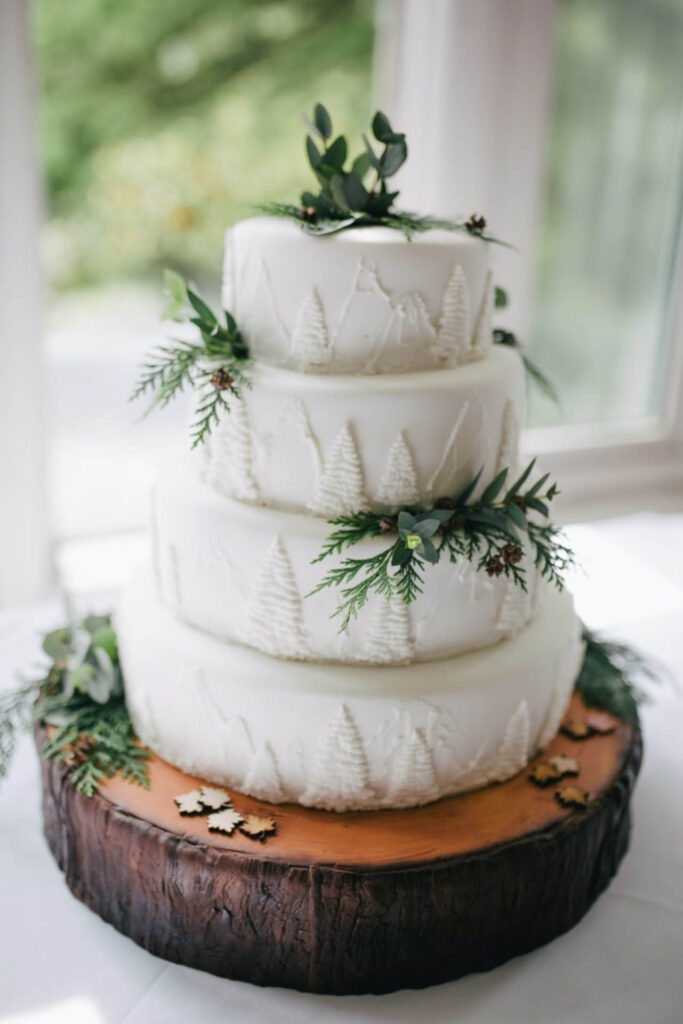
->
[131,270,251,449]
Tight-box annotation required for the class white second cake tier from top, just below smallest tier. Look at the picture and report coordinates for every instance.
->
[198,346,524,516]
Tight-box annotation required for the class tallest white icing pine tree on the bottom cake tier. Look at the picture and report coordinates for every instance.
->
[301,705,376,811]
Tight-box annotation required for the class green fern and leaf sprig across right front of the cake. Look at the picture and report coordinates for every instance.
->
[311,460,573,631]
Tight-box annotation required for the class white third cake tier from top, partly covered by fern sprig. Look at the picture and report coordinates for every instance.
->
[157,461,548,665]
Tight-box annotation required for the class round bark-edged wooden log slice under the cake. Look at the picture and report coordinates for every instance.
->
[42,696,641,993]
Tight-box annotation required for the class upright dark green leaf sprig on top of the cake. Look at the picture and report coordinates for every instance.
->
[258,103,506,245]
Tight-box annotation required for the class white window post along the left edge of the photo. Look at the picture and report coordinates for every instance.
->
[0,0,51,607]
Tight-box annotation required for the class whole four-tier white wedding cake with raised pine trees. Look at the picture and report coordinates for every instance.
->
[119,211,581,811]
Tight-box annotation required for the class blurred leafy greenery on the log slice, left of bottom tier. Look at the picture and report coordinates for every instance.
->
[0,615,148,797]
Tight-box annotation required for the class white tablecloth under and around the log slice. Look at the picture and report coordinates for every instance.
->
[0,515,683,1024]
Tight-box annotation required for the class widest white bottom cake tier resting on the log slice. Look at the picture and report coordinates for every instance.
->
[118,569,582,811]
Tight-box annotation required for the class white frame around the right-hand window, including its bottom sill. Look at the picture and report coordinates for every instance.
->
[375,0,683,521]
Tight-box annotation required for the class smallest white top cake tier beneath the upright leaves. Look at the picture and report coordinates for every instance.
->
[222,217,494,374]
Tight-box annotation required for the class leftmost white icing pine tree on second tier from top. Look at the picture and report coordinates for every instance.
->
[206,401,258,501]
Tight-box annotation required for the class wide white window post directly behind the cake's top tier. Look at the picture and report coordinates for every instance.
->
[375,0,555,332]
